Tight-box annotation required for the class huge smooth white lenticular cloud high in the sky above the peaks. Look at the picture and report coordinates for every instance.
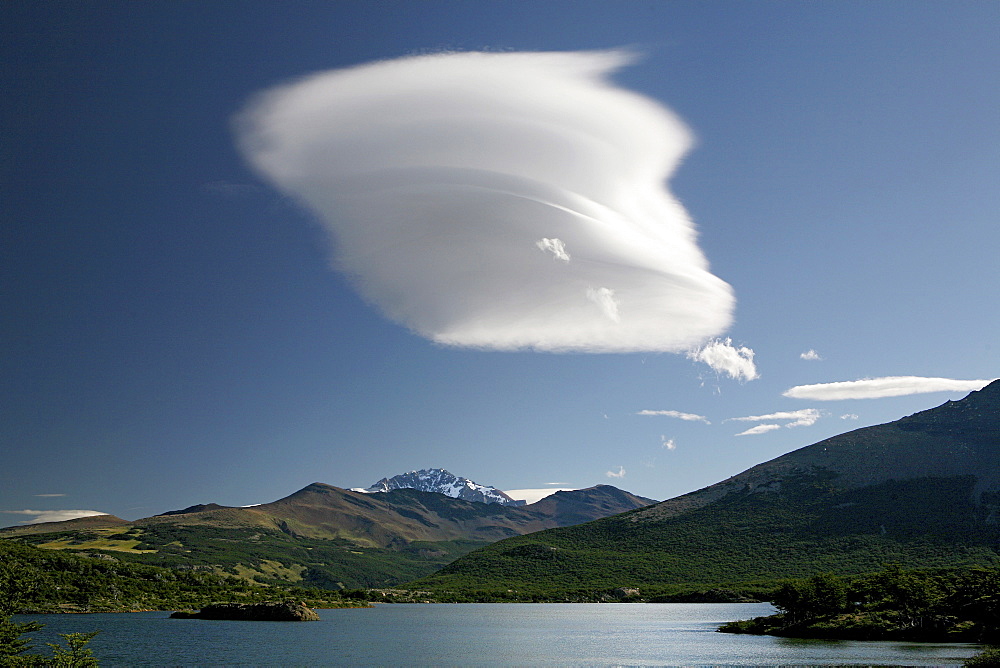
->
[238,51,733,352]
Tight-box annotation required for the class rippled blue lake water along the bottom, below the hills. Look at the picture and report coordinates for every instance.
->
[17,603,978,666]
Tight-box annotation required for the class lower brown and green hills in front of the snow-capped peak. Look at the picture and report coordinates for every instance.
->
[0,472,655,588]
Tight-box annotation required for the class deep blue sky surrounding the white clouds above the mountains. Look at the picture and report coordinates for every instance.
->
[0,1,1000,524]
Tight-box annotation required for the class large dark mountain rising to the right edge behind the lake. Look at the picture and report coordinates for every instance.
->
[413,380,1000,598]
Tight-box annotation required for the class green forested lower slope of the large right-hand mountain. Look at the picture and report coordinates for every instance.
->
[410,472,1000,599]
